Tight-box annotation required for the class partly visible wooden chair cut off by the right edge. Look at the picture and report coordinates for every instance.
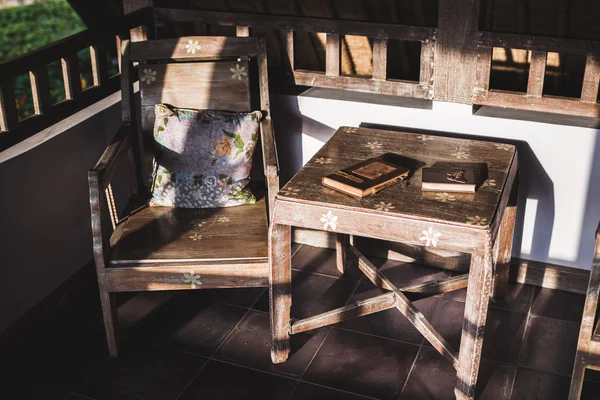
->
[569,225,600,400]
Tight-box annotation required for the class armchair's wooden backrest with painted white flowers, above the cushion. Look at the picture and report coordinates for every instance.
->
[122,36,269,188]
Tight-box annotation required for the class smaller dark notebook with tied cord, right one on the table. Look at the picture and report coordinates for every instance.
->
[421,162,487,193]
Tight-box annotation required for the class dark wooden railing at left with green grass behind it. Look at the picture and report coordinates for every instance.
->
[0,9,152,151]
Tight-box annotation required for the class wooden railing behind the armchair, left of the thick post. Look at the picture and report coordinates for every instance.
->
[155,8,436,100]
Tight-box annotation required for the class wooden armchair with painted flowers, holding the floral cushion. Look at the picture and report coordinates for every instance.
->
[89,37,279,356]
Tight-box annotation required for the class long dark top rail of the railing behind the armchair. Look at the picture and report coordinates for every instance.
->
[155,8,436,41]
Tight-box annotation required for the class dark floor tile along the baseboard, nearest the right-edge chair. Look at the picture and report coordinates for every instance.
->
[531,288,585,322]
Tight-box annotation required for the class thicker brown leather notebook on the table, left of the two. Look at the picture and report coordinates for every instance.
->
[322,153,410,198]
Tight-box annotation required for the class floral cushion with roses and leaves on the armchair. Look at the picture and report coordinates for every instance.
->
[150,104,262,208]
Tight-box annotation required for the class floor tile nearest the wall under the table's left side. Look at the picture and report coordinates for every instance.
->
[292,245,362,280]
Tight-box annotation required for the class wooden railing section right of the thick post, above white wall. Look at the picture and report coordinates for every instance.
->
[473,32,600,118]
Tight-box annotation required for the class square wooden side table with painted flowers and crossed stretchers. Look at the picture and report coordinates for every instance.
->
[269,127,517,399]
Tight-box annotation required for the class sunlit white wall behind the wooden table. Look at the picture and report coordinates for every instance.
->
[273,88,600,269]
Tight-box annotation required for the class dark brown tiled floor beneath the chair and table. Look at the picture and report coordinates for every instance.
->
[0,246,600,400]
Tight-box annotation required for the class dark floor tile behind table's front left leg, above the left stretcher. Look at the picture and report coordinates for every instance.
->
[255,268,357,319]
